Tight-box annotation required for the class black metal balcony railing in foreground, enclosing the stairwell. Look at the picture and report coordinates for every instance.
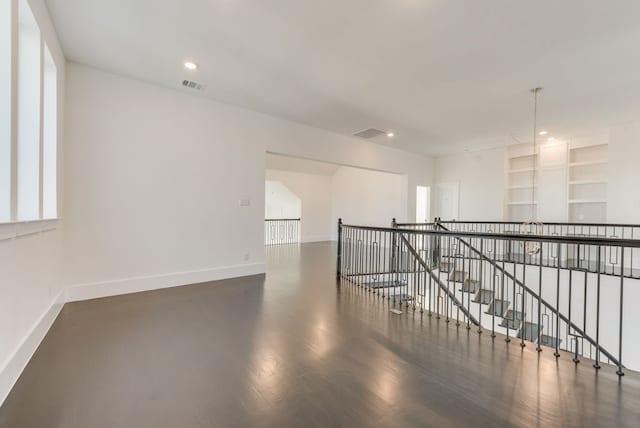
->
[337,222,640,376]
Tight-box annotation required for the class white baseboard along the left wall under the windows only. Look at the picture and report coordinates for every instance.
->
[0,290,65,405]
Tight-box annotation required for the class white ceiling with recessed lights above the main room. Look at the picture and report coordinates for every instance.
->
[48,0,640,155]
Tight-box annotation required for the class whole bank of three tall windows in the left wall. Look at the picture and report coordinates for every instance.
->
[0,0,58,223]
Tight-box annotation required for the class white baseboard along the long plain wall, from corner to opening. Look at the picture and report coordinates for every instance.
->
[66,263,265,302]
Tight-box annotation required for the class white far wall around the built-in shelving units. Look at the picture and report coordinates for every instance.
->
[434,122,640,224]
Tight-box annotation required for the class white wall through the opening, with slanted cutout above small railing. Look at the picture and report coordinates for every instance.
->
[266,169,333,242]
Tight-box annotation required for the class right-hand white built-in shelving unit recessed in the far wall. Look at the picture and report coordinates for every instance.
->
[567,142,608,223]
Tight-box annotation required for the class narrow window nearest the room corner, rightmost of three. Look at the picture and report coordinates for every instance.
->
[42,44,58,218]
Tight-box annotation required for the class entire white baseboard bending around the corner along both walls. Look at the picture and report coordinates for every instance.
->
[0,263,265,406]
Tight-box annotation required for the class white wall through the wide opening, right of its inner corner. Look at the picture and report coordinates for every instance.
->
[332,167,408,239]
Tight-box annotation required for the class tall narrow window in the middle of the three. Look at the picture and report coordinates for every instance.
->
[17,0,42,220]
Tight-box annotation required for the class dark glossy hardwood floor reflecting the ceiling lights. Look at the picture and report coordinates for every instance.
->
[0,243,640,428]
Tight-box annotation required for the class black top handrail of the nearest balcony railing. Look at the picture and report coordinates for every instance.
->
[342,223,640,248]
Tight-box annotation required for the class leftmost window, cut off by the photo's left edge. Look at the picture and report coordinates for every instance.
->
[0,1,12,222]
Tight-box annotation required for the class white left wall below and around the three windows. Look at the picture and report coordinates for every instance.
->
[0,0,66,403]
